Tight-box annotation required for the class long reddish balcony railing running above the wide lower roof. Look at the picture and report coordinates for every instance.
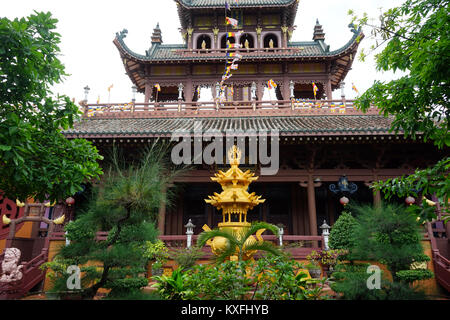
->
[81,99,379,118]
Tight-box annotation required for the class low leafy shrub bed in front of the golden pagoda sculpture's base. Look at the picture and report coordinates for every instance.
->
[180,254,326,300]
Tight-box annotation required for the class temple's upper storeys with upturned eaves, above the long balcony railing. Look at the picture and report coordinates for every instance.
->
[114,0,364,103]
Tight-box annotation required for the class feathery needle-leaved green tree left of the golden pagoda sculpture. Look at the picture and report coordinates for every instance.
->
[50,143,186,298]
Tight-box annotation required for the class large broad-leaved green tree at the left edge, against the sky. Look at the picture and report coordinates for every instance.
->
[0,12,102,200]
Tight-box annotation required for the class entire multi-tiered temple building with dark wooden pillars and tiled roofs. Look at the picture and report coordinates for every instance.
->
[64,0,445,236]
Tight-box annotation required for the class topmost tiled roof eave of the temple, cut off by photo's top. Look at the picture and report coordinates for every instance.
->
[179,0,297,8]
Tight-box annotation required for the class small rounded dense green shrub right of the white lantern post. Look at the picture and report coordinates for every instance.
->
[329,211,358,250]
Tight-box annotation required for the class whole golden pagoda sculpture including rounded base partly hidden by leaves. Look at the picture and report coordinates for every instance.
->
[203,146,265,260]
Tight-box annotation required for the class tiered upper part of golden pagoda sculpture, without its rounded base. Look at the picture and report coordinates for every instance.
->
[205,146,265,223]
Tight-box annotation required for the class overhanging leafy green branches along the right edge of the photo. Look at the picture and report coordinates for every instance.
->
[350,0,450,220]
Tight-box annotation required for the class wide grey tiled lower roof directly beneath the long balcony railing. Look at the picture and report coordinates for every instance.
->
[65,115,391,137]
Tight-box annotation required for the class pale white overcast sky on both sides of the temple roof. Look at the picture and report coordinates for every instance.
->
[0,0,403,103]
